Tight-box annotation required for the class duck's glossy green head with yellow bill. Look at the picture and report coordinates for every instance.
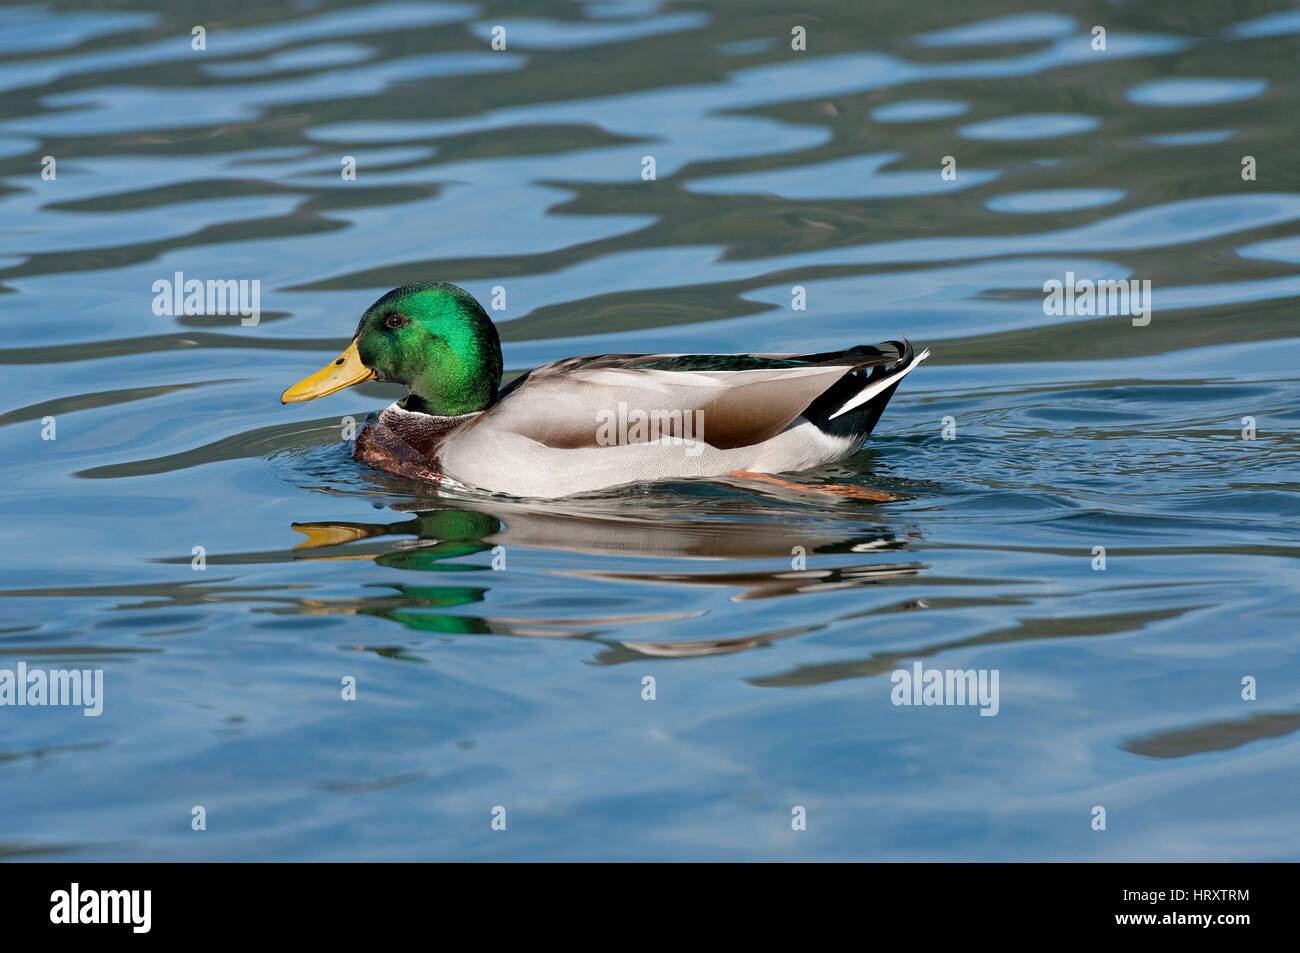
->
[280,281,501,416]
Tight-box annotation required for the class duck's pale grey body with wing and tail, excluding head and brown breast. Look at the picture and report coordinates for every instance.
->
[437,342,926,497]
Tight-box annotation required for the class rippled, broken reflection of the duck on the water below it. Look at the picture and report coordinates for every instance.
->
[279,498,923,655]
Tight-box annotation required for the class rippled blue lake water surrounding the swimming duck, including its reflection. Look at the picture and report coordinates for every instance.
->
[0,0,1300,859]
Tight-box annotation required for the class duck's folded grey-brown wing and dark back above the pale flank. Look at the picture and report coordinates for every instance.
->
[471,342,911,450]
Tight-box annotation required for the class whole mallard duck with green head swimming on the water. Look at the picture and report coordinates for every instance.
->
[281,282,930,498]
